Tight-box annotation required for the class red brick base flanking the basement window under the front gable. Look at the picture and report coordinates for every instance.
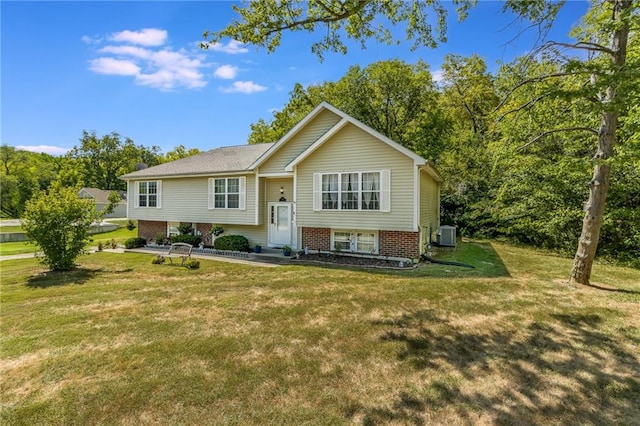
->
[302,228,420,259]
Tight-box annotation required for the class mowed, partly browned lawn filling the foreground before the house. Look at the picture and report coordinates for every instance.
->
[0,243,640,425]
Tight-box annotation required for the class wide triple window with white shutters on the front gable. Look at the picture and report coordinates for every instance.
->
[313,170,390,212]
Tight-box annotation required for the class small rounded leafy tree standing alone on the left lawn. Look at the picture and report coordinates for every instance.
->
[22,184,102,271]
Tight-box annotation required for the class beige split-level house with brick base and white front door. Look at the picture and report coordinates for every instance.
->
[121,103,442,258]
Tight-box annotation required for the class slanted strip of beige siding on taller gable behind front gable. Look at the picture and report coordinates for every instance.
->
[260,110,340,174]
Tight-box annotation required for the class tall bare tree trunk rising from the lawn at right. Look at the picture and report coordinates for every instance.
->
[569,0,632,285]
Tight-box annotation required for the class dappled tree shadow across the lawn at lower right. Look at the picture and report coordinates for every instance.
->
[345,310,640,425]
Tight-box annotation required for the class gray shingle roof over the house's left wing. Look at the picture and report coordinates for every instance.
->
[120,143,274,179]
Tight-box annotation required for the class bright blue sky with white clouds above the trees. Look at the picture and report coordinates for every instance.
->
[0,1,587,155]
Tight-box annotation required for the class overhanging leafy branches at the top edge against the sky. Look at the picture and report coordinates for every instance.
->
[205,0,475,59]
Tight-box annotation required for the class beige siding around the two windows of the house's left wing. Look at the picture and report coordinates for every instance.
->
[127,175,256,225]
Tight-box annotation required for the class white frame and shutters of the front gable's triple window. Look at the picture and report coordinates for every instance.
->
[313,170,391,213]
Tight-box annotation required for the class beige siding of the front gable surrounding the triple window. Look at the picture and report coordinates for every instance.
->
[296,124,417,231]
